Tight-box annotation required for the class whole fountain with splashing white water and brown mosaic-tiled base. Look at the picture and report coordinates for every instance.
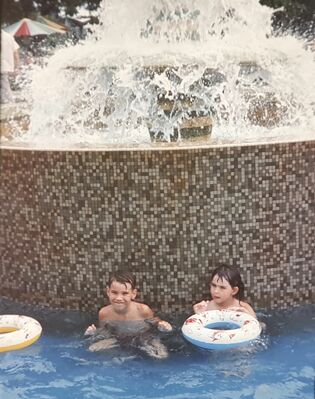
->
[0,0,315,312]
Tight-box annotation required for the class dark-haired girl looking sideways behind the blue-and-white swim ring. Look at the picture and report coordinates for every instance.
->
[193,265,256,317]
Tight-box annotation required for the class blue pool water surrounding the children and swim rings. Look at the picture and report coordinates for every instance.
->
[0,299,315,399]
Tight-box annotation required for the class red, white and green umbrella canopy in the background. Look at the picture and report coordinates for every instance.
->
[4,18,65,37]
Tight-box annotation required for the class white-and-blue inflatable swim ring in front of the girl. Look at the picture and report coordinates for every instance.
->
[182,310,261,349]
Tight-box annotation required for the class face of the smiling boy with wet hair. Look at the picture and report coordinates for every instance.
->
[106,281,137,312]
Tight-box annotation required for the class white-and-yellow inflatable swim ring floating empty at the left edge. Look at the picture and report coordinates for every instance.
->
[0,314,42,352]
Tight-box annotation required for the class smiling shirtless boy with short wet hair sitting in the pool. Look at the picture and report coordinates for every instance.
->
[85,271,172,359]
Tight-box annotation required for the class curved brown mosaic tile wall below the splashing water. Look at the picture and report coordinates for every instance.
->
[0,141,315,313]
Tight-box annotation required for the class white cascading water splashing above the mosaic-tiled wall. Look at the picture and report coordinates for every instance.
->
[7,0,315,148]
